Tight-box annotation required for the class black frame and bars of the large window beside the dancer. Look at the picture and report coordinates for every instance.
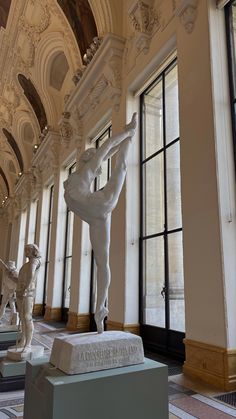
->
[139,58,185,359]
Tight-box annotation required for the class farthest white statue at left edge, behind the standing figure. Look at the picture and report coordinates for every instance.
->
[0,259,18,324]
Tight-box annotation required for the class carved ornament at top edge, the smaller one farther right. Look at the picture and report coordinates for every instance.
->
[175,0,198,33]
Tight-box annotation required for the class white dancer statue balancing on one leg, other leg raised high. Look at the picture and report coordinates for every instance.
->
[64,113,137,333]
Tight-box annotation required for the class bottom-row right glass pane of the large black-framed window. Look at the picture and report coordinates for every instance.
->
[168,231,185,332]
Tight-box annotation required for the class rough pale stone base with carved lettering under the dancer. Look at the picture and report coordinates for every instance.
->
[50,331,144,374]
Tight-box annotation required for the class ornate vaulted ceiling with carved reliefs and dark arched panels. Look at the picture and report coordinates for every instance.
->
[0,0,97,206]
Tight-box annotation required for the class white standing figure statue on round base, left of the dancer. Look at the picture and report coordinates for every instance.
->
[16,244,41,352]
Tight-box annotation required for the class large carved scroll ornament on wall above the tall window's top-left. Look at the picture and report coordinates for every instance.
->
[129,0,160,54]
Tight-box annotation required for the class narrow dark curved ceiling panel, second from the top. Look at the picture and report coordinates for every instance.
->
[18,74,47,131]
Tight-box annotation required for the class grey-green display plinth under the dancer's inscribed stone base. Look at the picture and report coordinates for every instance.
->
[24,359,168,419]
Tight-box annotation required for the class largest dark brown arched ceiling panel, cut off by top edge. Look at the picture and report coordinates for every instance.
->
[57,0,98,57]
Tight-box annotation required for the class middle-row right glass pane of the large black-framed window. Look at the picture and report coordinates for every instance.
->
[166,141,182,230]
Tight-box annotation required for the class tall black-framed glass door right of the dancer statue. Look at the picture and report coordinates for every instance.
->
[140,61,185,356]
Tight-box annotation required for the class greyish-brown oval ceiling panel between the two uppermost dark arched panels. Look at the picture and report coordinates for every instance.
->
[49,51,69,91]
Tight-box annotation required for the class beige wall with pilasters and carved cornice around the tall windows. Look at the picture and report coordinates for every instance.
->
[0,0,236,366]
